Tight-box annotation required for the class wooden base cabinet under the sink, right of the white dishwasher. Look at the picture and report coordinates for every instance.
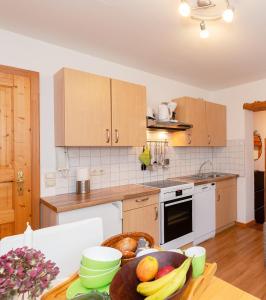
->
[216,178,237,231]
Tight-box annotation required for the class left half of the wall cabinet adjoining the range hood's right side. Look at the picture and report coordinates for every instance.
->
[171,97,208,146]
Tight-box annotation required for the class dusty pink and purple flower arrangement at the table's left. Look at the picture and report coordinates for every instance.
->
[0,247,59,299]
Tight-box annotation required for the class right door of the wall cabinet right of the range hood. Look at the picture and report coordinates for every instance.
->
[206,102,226,146]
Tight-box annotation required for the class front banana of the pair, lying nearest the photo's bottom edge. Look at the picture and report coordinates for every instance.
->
[145,258,191,300]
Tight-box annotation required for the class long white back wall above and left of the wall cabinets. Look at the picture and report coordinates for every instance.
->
[0,30,208,195]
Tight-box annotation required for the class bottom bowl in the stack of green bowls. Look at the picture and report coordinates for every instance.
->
[79,267,119,289]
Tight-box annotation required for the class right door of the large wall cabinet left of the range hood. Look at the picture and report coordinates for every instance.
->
[111,79,147,146]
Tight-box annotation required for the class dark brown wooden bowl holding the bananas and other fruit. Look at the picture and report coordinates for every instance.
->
[110,251,192,300]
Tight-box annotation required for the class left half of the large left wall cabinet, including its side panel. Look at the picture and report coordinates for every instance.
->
[55,68,111,146]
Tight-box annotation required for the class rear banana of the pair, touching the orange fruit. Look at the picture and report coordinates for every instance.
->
[137,258,191,296]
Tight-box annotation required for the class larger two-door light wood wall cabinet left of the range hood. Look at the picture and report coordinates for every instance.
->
[54,68,146,146]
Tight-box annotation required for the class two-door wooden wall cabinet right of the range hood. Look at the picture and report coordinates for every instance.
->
[170,97,226,147]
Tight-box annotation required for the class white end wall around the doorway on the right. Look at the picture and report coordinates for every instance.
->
[210,79,266,222]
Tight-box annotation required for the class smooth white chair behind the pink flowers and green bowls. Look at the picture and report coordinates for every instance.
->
[0,218,103,281]
